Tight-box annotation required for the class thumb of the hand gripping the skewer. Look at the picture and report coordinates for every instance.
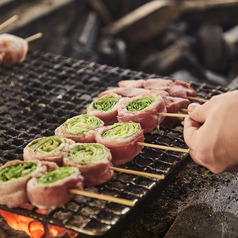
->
[188,103,206,123]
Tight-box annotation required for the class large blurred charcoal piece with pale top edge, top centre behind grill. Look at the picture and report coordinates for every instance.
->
[102,1,180,45]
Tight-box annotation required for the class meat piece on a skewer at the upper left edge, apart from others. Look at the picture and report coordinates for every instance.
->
[0,33,28,65]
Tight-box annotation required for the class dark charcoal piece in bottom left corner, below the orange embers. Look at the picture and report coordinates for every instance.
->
[0,215,30,238]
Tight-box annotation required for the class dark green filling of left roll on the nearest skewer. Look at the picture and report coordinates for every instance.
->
[0,162,37,182]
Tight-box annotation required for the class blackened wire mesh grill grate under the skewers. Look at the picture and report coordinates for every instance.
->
[0,52,227,237]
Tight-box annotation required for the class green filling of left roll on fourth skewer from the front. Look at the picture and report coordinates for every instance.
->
[92,96,119,112]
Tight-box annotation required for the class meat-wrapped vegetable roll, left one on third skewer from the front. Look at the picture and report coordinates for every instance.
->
[55,114,104,143]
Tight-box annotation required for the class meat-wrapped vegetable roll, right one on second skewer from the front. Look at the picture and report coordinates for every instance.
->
[63,143,113,186]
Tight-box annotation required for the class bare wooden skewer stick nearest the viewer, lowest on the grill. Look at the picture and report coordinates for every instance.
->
[69,189,137,207]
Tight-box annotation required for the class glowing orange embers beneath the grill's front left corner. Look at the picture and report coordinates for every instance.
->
[0,209,77,238]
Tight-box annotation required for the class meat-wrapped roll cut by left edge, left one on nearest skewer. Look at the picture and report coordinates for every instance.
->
[0,160,57,208]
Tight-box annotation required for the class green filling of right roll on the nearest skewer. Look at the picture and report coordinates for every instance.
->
[36,167,76,184]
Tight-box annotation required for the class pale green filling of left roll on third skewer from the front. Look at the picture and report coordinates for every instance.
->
[64,114,101,135]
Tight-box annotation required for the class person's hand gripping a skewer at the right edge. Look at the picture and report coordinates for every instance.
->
[184,91,238,174]
